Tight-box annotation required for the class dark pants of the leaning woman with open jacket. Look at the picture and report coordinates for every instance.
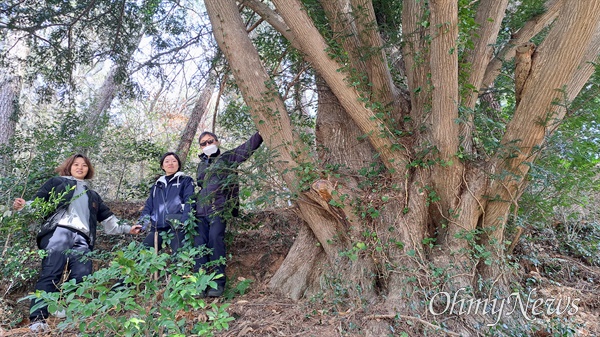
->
[29,226,92,321]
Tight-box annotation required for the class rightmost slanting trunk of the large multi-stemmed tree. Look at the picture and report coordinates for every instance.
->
[481,1,600,278]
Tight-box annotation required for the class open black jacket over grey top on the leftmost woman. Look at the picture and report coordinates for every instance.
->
[35,177,113,250]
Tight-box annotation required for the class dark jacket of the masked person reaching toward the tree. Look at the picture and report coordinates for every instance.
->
[196,132,263,216]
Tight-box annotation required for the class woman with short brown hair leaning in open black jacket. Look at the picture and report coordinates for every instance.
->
[13,154,141,332]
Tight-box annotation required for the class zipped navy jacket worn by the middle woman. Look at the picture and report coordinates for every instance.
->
[139,172,194,229]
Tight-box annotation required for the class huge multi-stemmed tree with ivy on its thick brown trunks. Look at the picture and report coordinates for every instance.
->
[205,0,600,330]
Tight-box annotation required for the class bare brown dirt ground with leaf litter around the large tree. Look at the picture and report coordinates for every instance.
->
[0,204,600,337]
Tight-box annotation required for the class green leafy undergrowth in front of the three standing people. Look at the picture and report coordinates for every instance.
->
[26,242,234,336]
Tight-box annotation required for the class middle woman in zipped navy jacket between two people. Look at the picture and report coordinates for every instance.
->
[138,152,194,253]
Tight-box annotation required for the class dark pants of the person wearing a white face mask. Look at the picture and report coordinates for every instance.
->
[194,215,226,287]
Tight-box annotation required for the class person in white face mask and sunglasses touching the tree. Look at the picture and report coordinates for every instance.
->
[194,131,263,297]
